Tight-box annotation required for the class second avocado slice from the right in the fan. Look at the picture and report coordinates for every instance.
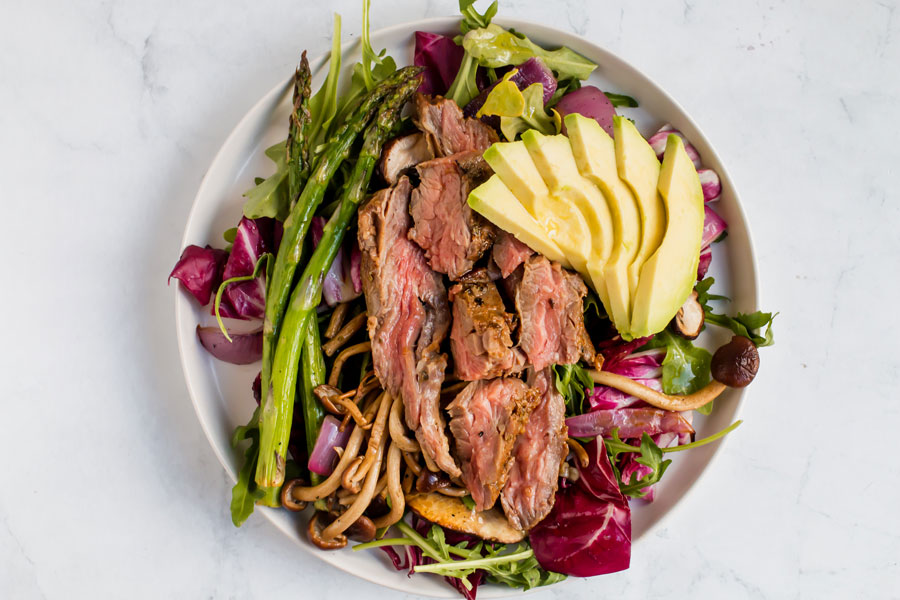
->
[613,116,666,296]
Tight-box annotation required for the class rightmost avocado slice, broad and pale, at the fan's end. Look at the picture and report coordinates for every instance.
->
[631,135,704,337]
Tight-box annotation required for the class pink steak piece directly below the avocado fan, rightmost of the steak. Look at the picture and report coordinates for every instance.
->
[514,254,596,371]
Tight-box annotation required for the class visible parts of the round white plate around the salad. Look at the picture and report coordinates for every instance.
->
[175,17,757,598]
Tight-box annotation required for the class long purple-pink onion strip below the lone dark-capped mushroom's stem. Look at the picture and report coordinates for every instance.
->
[566,408,694,439]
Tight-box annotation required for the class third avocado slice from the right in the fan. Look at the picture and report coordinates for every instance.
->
[565,113,641,339]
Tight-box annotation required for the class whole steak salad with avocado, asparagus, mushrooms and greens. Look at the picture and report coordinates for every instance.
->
[170,0,775,598]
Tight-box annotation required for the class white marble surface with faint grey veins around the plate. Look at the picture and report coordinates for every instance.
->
[0,0,900,598]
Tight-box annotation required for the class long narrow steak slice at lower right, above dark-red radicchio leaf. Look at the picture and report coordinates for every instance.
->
[500,368,569,530]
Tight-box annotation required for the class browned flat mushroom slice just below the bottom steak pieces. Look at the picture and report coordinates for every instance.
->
[406,492,525,544]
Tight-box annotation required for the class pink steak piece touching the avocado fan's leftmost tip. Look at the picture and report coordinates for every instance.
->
[409,151,496,280]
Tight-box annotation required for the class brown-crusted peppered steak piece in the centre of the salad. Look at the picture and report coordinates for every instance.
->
[450,269,525,381]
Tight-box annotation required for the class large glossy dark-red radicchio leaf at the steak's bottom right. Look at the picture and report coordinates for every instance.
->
[529,439,631,577]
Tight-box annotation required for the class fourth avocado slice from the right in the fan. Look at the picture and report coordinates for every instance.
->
[522,129,615,314]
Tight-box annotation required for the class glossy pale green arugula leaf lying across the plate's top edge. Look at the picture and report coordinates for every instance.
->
[462,24,597,79]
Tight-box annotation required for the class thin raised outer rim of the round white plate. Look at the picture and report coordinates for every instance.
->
[173,15,759,598]
